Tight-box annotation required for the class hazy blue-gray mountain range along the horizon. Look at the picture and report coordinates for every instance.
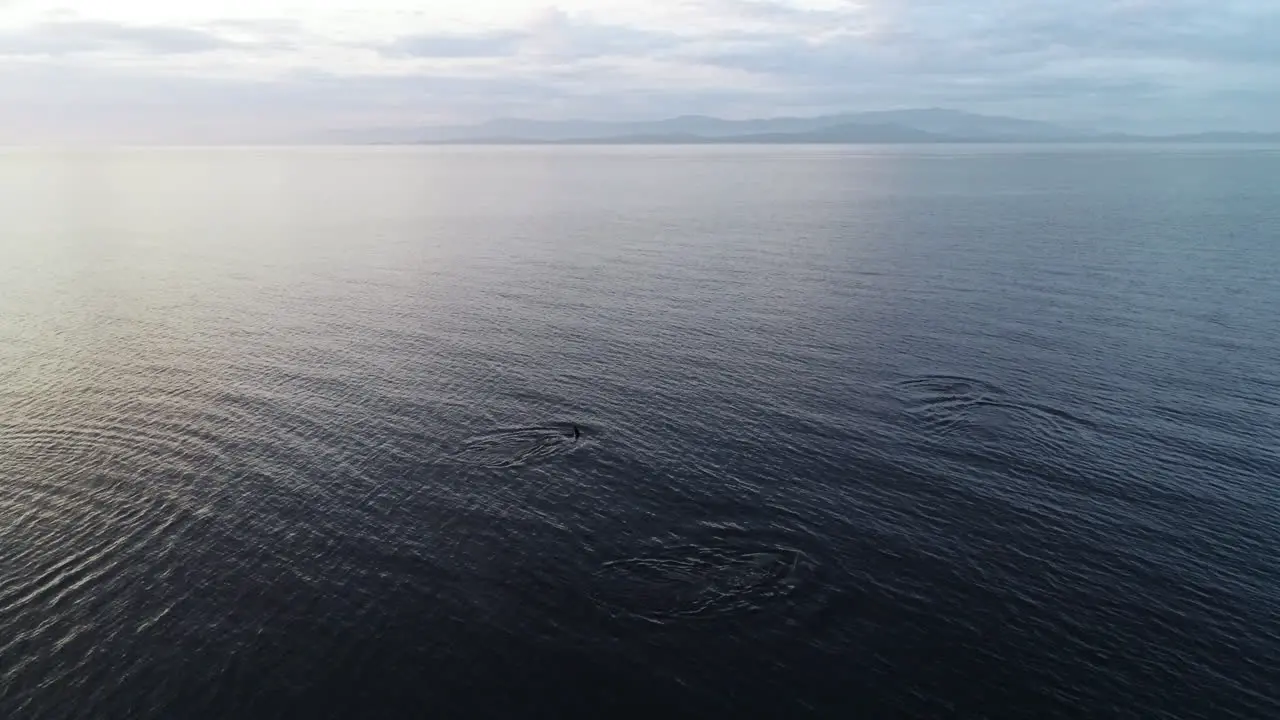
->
[343,108,1280,145]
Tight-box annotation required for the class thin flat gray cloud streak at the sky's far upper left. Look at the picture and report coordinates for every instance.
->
[0,20,234,55]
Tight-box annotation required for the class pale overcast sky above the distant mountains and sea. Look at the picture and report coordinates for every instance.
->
[0,0,1280,142]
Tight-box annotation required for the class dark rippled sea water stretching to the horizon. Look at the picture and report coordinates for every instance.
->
[0,142,1280,720]
